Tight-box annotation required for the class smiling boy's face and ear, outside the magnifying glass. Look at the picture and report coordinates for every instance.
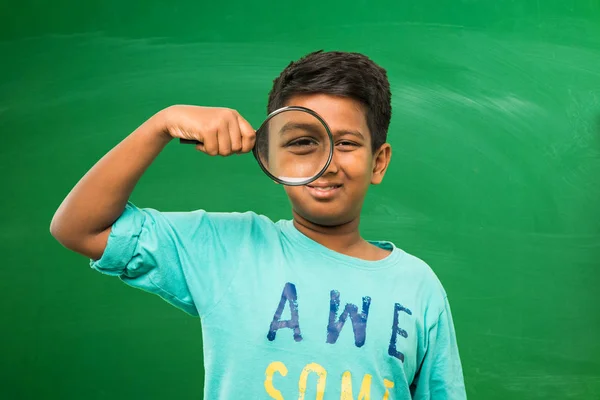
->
[285,95,391,226]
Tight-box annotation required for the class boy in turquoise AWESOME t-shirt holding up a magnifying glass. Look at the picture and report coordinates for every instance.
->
[51,51,466,400]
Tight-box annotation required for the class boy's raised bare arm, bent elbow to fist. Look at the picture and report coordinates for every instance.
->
[50,106,254,259]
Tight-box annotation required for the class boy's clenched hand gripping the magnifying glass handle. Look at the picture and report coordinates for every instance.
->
[161,105,256,156]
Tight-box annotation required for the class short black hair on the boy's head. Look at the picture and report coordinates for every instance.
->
[267,50,392,152]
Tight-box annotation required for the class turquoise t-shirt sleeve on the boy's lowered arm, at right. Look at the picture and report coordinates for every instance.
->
[411,297,467,400]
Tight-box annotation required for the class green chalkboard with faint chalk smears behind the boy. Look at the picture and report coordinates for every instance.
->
[0,0,600,400]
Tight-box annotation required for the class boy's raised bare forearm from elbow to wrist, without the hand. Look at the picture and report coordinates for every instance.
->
[50,108,171,256]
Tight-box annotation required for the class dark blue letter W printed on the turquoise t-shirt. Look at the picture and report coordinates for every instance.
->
[327,290,371,347]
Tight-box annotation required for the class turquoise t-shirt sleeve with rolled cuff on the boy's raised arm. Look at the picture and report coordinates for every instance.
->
[90,202,262,316]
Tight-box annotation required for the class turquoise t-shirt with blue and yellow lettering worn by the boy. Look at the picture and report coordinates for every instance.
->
[91,203,466,400]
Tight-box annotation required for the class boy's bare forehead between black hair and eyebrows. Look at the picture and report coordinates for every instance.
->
[285,94,370,138]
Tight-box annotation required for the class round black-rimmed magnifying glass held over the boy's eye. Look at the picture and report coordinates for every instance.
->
[179,106,333,186]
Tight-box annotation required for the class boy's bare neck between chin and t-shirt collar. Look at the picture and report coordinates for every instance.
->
[293,211,366,254]
